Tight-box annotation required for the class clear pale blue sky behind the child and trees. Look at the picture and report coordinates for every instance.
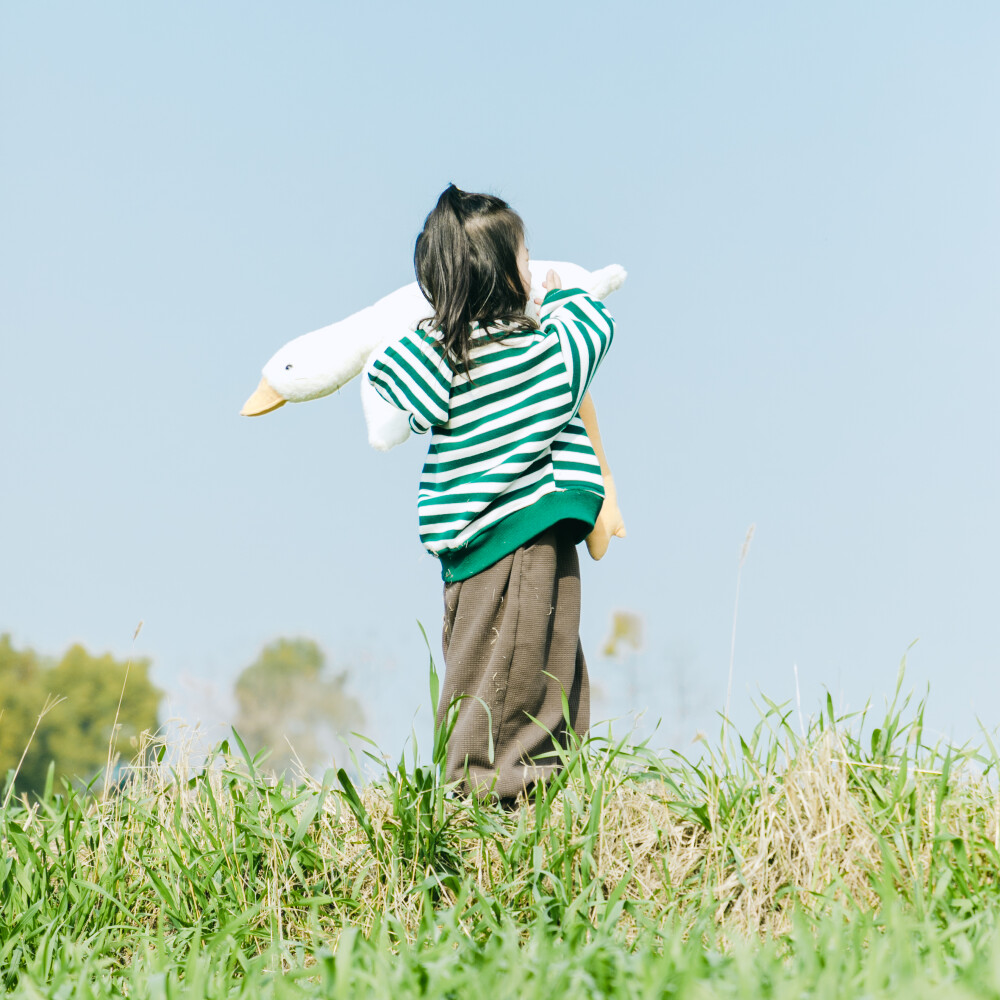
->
[0,0,1000,753]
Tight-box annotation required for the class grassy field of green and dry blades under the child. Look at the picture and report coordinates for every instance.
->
[0,675,1000,1000]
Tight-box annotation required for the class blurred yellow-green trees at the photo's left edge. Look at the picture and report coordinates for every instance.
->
[0,635,161,793]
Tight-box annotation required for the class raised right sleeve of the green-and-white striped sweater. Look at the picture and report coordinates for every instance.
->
[539,288,615,413]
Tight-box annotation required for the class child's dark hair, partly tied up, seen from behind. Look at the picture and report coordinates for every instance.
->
[413,184,538,374]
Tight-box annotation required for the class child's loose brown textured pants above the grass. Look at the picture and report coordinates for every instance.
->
[437,524,590,801]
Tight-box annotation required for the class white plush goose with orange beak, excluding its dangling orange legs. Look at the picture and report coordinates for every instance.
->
[240,260,626,451]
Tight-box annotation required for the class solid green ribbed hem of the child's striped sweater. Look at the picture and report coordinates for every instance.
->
[438,490,604,583]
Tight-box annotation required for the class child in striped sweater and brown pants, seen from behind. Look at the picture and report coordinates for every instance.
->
[367,185,624,803]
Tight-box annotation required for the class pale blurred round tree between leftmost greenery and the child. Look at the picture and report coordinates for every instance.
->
[234,639,364,773]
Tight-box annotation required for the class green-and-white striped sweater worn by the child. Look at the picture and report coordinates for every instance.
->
[366,288,614,581]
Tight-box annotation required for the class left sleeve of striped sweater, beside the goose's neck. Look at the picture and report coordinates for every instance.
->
[365,329,451,434]
